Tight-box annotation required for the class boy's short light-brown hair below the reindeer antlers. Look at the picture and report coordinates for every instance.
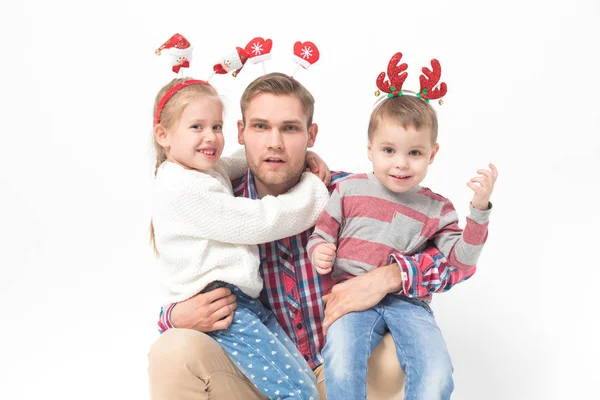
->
[368,95,438,143]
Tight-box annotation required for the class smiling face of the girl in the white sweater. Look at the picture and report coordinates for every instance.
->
[163,96,225,171]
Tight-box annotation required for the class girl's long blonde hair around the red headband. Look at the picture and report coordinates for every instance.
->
[150,78,224,256]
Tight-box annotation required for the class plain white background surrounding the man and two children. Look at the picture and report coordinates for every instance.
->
[0,0,600,399]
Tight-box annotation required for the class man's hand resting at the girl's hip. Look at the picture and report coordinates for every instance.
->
[171,287,237,332]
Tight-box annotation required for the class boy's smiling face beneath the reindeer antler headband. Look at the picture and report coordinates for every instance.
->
[369,120,439,193]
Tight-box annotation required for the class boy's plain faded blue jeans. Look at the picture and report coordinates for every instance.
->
[323,295,454,400]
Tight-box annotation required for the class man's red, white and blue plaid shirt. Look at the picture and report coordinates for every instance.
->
[158,170,475,369]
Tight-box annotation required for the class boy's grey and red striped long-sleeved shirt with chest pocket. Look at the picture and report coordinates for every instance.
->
[308,173,491,295]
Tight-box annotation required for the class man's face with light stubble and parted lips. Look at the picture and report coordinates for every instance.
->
[238,93,318,194]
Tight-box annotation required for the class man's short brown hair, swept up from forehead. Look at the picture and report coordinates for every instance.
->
[240,72,315,128]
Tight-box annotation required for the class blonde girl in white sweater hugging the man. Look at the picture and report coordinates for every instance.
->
[152,78,329,400]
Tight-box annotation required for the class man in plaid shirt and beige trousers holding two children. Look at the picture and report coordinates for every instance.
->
[148,73,468,400]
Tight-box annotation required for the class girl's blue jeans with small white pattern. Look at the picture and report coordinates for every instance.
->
[208,284,319,400]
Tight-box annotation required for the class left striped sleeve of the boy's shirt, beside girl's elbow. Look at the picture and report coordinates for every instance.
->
[306,185,343,264]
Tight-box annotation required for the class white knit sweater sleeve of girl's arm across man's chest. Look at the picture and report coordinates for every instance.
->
[158,173,329,244]
